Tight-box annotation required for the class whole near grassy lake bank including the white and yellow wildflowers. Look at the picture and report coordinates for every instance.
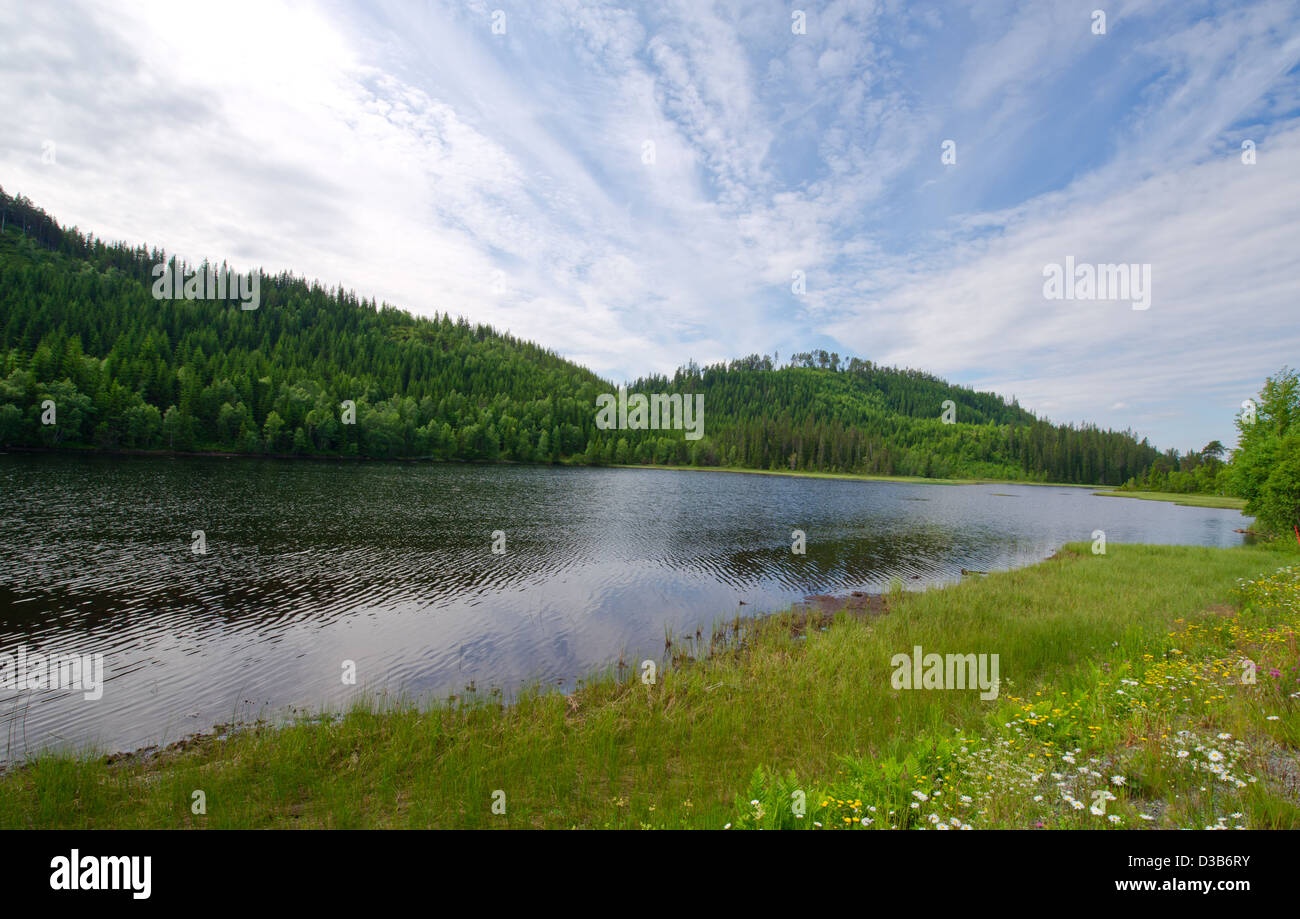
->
[0,543,1300,828]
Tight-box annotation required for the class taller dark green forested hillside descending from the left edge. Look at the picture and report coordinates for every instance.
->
[0,192,608,461]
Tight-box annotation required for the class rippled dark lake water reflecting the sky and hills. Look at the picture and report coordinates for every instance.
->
[0,455,1245,759]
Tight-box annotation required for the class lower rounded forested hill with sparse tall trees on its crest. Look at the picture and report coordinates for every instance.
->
[627,355,1158,485]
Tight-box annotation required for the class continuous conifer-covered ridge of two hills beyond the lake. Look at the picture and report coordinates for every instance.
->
[0,191,1158,484]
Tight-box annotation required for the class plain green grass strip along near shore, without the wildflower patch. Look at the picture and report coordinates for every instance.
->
[0,543,1300,828]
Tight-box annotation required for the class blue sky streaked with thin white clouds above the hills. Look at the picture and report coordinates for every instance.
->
[0,0,1300,451]
